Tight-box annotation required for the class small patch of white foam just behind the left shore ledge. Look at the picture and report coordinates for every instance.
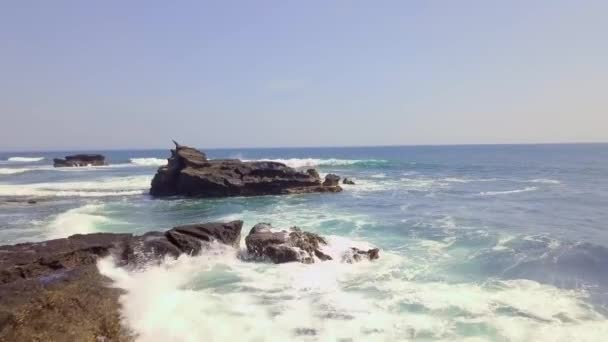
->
[47,204,110,239]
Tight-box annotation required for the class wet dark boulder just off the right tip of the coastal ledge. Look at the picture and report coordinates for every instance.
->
[245,223,331,264]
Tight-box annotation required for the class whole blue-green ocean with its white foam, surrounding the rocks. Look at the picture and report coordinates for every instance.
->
[0,144,608,341]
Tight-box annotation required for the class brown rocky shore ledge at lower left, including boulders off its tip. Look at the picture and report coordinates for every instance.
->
[0,221,379,341]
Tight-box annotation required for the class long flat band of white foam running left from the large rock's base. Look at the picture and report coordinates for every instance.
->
[0,176,152,197]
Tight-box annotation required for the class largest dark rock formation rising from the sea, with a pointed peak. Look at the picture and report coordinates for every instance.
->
[150,143,342,197]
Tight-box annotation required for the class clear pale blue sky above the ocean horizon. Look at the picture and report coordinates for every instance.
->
[0,0,608,151]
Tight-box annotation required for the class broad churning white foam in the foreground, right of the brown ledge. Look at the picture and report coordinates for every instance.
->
[98,237,608,342]
